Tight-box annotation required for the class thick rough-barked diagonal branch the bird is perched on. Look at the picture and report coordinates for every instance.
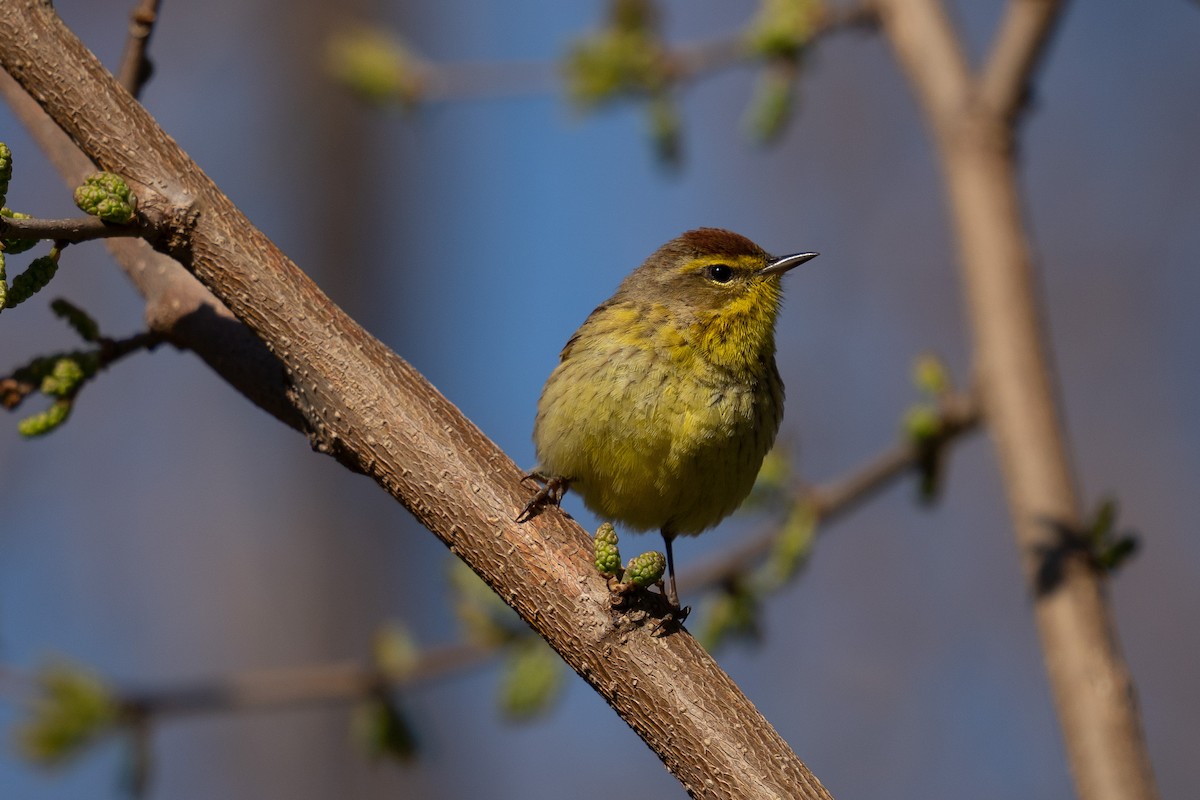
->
[0,0,829,798]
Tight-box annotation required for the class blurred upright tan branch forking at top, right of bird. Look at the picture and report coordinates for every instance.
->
[880,0,1157,800]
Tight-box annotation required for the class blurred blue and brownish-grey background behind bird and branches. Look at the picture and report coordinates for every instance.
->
[0,0,1200,800]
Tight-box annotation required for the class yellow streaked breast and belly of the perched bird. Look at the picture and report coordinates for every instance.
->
[534,299,784,534]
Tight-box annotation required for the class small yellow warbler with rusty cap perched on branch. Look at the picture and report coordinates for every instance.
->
[517,228,817,620]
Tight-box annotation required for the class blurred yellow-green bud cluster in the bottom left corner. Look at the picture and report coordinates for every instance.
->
[17,664,119,766]
